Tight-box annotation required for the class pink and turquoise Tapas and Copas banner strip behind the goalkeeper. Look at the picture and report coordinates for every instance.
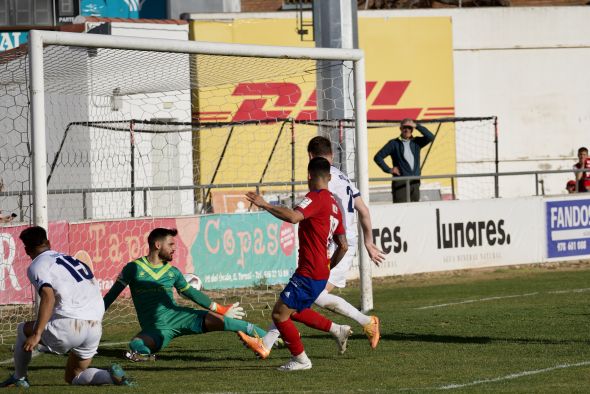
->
[0,212,297,305]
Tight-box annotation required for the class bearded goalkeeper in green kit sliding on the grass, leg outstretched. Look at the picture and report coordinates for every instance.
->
[104,228,266,361]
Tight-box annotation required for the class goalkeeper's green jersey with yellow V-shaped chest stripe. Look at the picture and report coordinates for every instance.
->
[117,257,192,329]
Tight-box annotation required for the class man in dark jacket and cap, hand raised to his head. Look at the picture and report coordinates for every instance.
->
[374,119,434,203]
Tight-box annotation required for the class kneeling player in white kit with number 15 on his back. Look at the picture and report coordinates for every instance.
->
[0,226,130,388]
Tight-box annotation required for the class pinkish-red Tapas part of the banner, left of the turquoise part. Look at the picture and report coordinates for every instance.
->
[0,218,194,305]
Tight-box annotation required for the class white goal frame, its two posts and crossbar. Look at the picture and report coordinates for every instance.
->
[28,30,373,311]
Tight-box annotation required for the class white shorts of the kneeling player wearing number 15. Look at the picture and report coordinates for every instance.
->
[41,316,102,360]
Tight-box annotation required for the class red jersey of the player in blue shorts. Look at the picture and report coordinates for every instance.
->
[295,189,345,280]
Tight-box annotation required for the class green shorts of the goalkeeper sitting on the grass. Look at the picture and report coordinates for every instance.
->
[138,308,209,352]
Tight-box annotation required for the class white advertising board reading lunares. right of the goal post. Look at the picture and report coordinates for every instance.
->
[370,197,545,276]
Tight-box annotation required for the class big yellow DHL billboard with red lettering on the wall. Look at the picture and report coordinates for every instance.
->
[190,17,456,189]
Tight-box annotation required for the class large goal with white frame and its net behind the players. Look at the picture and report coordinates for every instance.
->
[0,32,372,341]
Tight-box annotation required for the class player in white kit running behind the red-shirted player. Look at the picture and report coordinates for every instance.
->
[307,136,385,349]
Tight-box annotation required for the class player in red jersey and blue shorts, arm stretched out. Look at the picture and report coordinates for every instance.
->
[238,157,352,371]
